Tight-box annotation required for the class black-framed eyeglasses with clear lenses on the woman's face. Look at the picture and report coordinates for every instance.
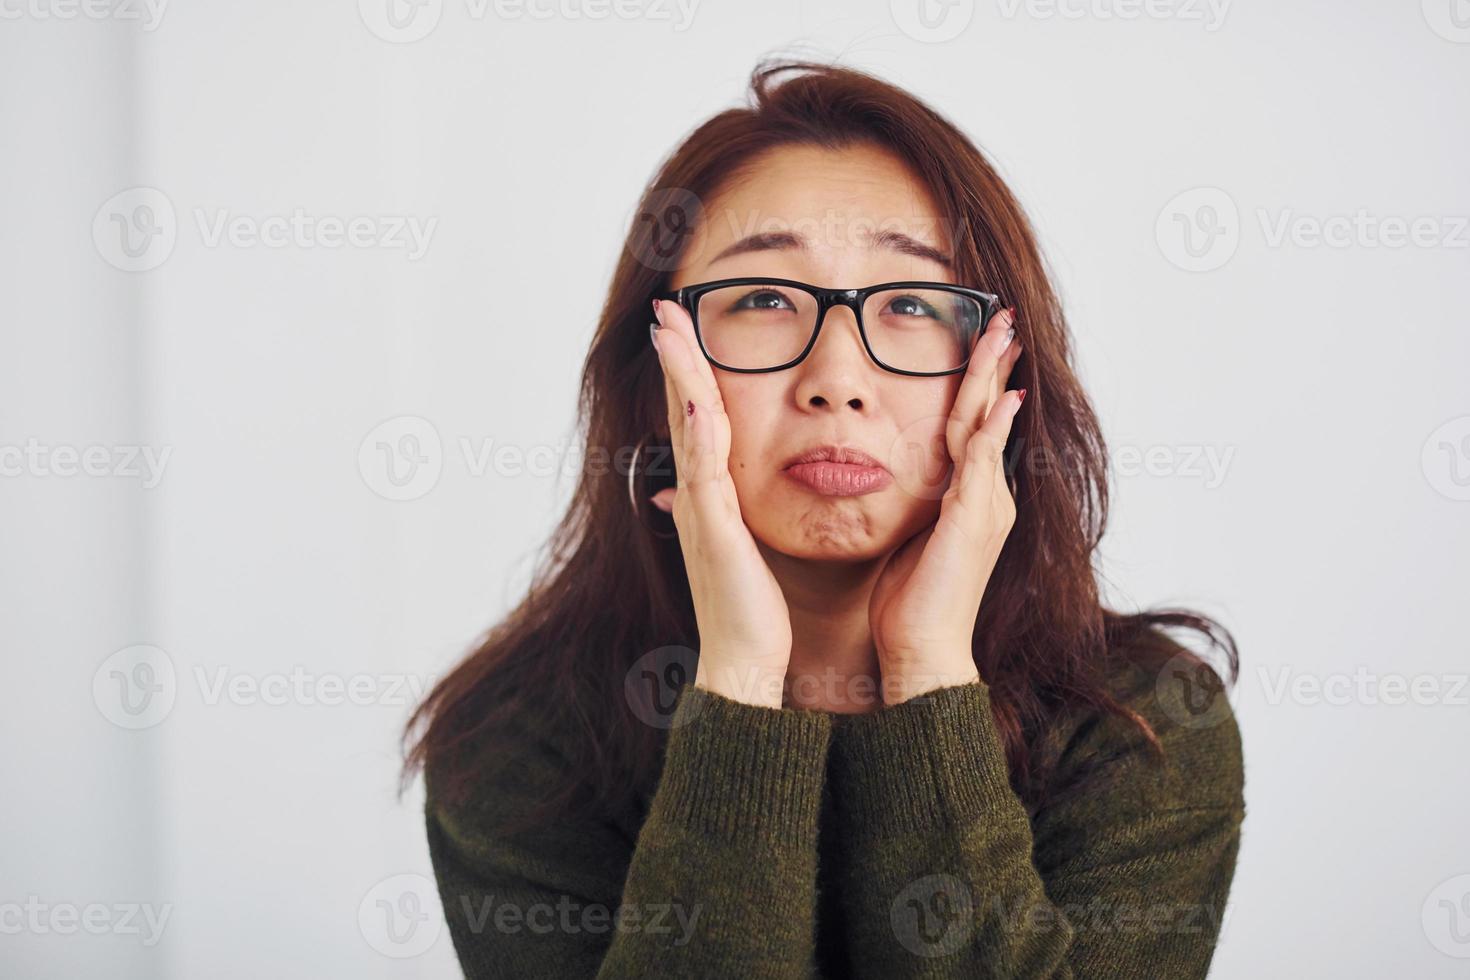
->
[656,276,1000,378]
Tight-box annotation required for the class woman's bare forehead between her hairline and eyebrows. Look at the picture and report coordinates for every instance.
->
[691,144,948,260]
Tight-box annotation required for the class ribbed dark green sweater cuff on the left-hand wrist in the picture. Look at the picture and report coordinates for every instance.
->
[650,683,832,843]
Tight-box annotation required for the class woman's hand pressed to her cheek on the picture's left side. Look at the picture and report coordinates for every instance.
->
[650,300,791,708]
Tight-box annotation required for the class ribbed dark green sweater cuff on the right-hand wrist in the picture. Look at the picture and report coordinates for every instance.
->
[832,682,1016,836]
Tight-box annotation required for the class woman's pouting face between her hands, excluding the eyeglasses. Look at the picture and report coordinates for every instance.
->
[672,147,970,560]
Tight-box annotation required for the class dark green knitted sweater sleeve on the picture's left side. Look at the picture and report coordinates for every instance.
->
[426,685,831,980]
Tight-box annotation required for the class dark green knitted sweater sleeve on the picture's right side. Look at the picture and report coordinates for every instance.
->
[831,669,1245,980]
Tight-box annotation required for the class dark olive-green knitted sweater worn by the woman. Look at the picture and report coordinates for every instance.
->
[426,655,1245,980]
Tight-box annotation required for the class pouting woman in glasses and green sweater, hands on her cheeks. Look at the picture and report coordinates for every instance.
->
[406,63,1244,979]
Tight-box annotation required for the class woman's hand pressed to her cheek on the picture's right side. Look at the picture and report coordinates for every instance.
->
[869,310,1025,704]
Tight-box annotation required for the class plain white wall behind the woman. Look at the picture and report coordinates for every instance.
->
[0,0,1470,979]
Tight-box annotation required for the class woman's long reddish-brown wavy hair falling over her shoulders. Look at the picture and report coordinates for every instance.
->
[401,60,1239,823]
